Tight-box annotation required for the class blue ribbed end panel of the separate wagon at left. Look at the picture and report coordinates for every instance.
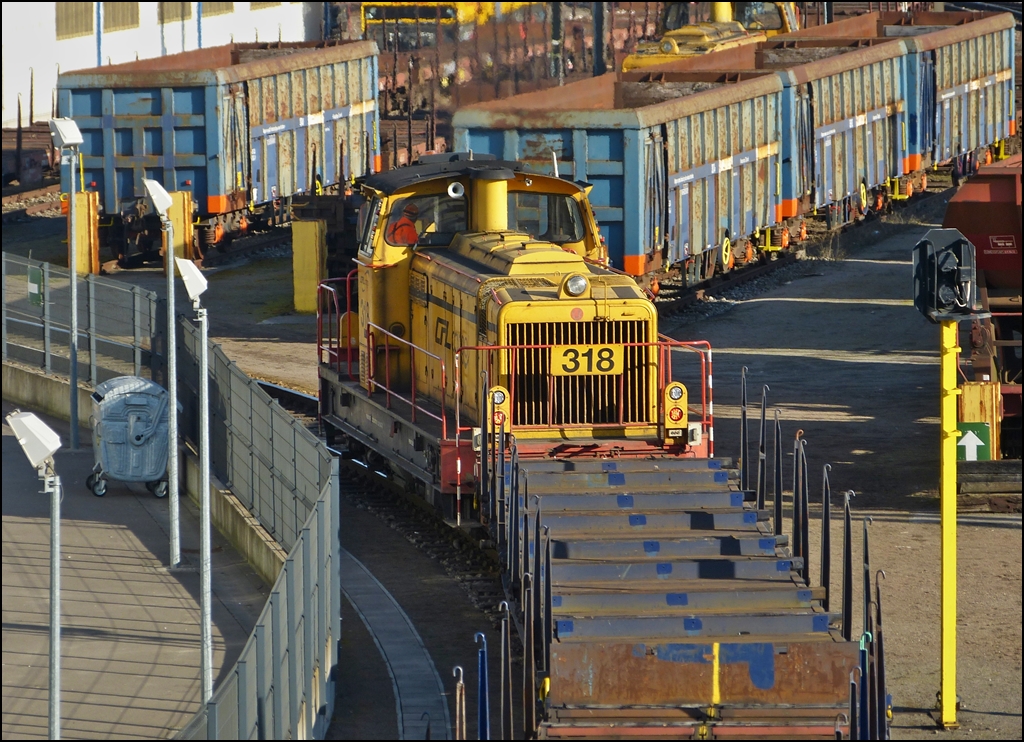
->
[57,85,221,214]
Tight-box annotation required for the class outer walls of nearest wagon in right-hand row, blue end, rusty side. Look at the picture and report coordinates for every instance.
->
[455,80,781,275]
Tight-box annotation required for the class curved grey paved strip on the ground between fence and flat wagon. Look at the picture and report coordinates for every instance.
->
[341,549,452,739]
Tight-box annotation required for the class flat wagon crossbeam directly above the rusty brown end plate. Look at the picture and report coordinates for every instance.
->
[554,610,840,643]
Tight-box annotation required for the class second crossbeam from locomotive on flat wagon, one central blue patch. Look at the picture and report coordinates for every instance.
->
[520,465,729,494]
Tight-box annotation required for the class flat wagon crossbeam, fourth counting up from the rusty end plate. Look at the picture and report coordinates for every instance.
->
[551,532,790,561]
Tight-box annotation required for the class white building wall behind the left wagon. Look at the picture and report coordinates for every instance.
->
[0,2,324,128]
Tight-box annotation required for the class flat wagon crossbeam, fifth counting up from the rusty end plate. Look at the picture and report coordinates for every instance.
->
[541,509,769,537]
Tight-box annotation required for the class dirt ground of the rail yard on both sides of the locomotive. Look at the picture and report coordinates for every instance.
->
[3,188,1022,739]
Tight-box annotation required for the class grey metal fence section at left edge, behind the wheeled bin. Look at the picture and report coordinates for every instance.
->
[0,253,163,386]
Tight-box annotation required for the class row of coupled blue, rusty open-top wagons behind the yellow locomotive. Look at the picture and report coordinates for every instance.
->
[453,12,1017,283]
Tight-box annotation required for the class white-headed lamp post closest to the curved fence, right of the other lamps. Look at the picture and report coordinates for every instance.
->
[174,258,213,703]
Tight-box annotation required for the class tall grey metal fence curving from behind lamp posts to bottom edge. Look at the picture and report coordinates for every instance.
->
[178,319,341,739]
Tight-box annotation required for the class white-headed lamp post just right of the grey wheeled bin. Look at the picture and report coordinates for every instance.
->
[142,178,181,567]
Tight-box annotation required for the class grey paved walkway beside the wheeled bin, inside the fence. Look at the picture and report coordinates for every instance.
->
[3,402,267,739]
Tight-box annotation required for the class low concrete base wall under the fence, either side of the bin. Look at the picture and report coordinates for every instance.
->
[3,361,288,584]
